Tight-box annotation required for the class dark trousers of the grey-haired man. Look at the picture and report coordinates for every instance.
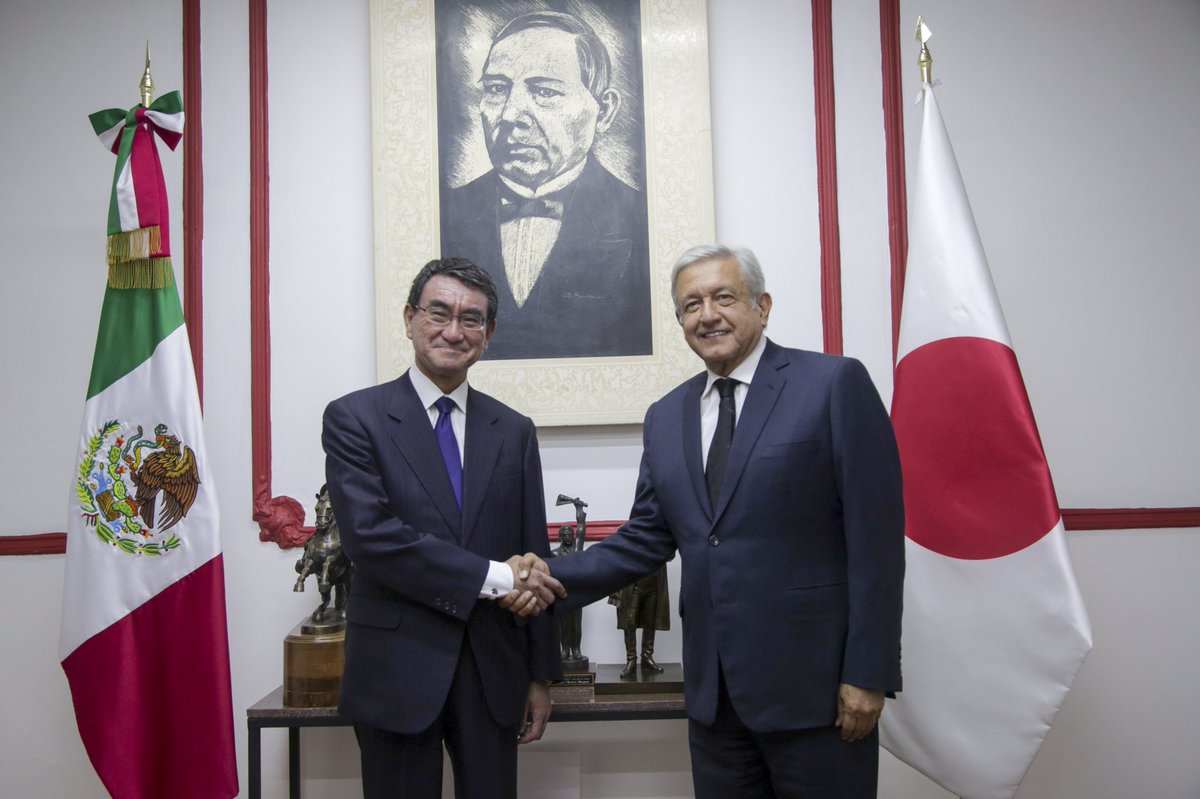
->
[688,675,880,799]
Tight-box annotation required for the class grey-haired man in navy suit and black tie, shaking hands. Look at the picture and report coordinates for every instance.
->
[523,246,904,799]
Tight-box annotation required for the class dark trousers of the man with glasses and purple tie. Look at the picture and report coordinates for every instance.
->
[354,639,517,799]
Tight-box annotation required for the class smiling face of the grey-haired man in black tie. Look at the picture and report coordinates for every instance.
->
[673,258,770,377]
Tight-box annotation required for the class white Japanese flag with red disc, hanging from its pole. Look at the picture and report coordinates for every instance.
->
[881,77,1092,799]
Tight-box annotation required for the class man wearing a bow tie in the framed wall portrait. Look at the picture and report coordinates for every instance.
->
[442,12,652,359]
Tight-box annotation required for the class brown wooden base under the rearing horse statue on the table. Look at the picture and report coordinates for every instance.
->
[283,617,346,708]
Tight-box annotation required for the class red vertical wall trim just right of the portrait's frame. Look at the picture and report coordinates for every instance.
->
[812,0,842,355]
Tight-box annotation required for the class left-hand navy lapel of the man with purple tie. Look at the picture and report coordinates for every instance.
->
[388,374,460,534]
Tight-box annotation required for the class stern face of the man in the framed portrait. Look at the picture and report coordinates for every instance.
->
[479,28,616,188]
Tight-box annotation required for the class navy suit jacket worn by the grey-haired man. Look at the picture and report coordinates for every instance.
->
[551,342,904,732]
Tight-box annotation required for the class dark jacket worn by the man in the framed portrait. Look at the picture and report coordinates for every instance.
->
[442,158,653,360]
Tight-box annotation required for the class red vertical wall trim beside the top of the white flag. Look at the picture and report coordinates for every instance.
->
[880,0,908,361]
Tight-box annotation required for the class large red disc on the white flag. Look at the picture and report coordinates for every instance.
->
[892,338,1061,560]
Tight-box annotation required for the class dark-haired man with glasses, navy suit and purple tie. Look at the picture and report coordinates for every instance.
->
[322,258,562,799]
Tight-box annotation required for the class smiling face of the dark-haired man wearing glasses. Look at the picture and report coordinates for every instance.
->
[404,275,496,394]
